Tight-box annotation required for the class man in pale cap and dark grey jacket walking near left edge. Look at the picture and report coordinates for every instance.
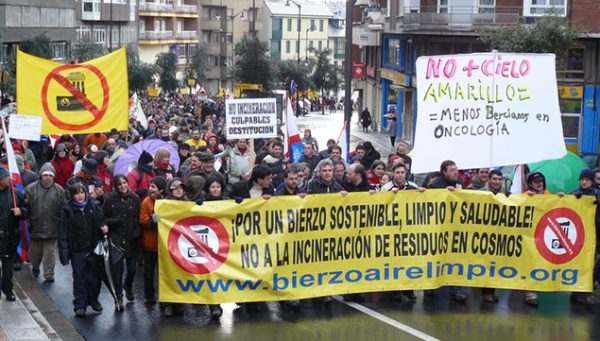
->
[25,162,66,283]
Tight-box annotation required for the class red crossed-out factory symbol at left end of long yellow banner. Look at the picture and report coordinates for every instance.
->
[167,216,229,275]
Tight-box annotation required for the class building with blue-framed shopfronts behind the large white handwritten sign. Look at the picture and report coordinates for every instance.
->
[353,0,600,153]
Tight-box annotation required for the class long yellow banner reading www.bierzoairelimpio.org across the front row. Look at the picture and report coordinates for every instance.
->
[156,189,596,303]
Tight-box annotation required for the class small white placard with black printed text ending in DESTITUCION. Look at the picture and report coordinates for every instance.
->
[225,98,277,139]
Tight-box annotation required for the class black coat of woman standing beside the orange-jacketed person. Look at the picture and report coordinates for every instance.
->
[102,191,142,257]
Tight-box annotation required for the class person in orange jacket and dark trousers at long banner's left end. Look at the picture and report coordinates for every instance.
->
[140,176,167,304]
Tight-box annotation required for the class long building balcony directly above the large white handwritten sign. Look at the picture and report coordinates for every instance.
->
[397,6,521,31]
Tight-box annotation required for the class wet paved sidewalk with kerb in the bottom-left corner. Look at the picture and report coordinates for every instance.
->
[0,265,83,341]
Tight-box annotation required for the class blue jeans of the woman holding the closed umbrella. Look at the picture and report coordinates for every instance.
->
[71,252,102,310]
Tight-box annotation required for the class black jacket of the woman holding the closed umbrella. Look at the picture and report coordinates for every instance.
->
[58,199,105,265]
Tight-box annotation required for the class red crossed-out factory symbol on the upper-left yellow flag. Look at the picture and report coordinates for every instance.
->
[41,64,110,131]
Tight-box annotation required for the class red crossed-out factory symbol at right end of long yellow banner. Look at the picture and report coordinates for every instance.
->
[535,207,585,264]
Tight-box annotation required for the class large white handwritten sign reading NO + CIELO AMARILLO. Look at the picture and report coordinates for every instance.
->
[411,52,566,173]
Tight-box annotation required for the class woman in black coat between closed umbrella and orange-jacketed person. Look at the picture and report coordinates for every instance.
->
[102,174,142,311]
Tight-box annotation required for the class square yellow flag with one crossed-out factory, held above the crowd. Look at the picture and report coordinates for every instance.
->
[17,49,129,134]
